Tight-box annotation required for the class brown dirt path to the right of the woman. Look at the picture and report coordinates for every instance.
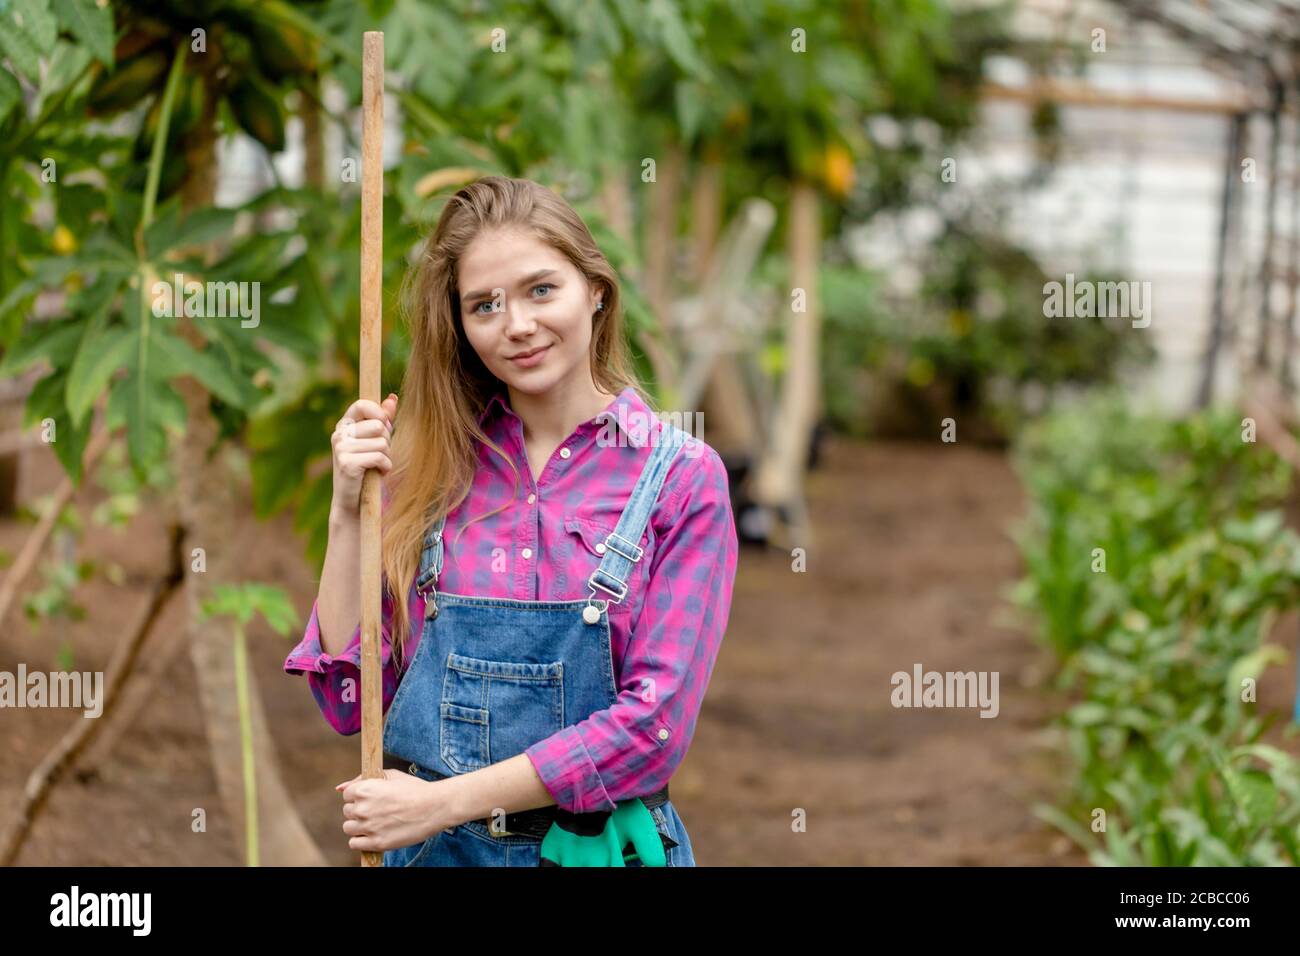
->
[672,442,1080,865]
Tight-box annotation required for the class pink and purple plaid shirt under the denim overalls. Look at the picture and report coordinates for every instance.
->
[285,388,737,813]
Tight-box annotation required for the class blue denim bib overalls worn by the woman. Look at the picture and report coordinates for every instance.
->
[384,423,696,866]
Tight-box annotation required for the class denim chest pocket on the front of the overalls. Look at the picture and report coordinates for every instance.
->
[439,653,564,774]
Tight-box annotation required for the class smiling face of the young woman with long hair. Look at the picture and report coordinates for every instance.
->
[456,229,601,395]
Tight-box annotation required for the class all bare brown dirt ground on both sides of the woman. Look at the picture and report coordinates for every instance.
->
[0,442,1079,865]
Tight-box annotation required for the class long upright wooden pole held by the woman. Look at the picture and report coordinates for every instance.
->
[360,30,384,866]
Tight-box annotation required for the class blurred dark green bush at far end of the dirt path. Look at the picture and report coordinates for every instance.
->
[822,220,1151,437]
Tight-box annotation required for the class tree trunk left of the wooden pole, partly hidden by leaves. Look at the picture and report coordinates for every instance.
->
[173,76,325,866]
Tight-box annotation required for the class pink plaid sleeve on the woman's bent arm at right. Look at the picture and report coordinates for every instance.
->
[525,445,738,813]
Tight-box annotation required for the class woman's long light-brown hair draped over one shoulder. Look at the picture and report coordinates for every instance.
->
[382,176,641,672]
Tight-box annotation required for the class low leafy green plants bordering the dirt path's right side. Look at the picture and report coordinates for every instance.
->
[1014,395,1300,865]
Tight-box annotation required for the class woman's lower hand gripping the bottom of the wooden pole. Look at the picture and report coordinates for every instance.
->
[334,770,458,852]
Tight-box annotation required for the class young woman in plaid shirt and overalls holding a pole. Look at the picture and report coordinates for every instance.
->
[285,176,737,866]
